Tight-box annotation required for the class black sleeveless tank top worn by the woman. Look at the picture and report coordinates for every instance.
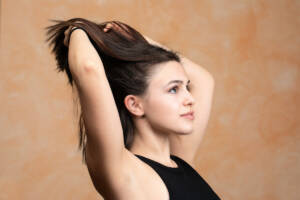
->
[134,154,220,200]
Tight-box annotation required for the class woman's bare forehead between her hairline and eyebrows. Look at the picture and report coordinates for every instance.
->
[150,61,187,86]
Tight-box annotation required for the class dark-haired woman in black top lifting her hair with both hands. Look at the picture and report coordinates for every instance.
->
[48,18,219,200]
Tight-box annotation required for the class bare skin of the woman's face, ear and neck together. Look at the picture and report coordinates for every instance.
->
[124,61,195,167]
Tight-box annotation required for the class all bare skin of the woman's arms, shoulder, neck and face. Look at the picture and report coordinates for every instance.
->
[65,21,214,200]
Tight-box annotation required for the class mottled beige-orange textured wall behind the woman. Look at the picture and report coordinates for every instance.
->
[0,0,300,200]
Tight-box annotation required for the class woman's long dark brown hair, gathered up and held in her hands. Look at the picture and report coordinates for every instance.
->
[46,18,180,163]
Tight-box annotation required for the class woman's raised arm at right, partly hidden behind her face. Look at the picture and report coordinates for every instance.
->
[144,36,214,167]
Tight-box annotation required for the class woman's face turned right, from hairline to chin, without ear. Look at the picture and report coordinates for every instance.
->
[143,61,195,134]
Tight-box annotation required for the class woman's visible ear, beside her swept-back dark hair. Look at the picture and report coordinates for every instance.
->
[124,95,144,117]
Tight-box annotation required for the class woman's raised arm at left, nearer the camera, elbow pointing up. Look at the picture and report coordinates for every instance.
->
[68,29,126,192]
